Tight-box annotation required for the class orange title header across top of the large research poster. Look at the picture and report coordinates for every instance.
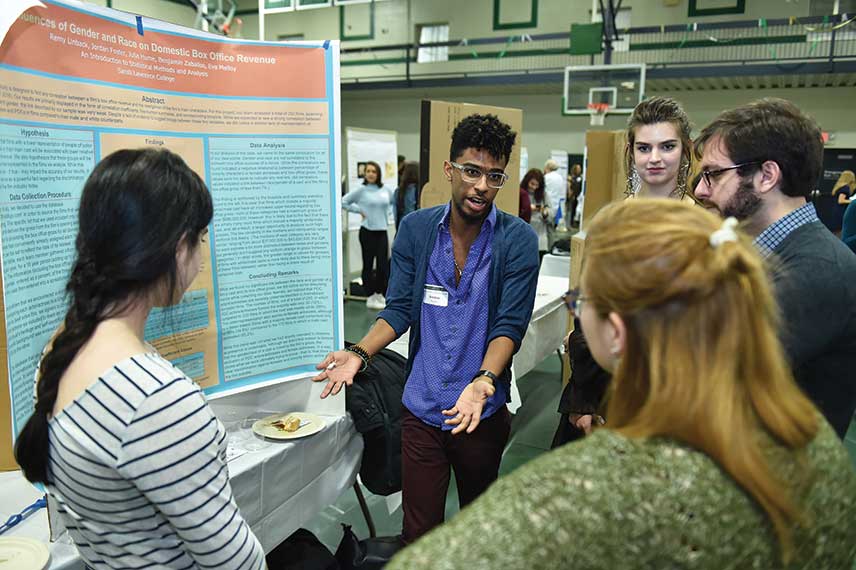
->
[0,5,327,99]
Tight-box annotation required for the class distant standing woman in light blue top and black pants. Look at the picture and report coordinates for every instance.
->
[342,162,393,310]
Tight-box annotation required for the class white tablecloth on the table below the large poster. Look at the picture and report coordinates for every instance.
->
[0,380,363,570]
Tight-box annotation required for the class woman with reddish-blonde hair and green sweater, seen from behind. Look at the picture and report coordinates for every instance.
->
[385,199,856,570]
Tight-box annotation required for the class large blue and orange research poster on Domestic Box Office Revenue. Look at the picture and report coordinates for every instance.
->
[0,0,343,468]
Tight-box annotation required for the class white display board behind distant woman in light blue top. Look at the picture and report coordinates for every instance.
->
[345,127,398,230]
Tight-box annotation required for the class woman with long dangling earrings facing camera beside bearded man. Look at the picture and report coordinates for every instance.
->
[552,97,695,447]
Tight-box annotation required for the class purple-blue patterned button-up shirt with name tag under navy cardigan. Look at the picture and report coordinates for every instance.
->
[402,205,507,430]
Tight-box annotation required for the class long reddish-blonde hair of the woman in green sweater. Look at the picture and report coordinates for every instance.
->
[583,199,819,561]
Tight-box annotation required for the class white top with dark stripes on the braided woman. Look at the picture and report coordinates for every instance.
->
[47,353,265,569]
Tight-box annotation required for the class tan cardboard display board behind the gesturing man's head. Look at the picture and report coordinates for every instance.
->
[419,100,523,216]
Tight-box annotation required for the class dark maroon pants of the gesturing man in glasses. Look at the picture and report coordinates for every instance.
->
[401,406,511,544]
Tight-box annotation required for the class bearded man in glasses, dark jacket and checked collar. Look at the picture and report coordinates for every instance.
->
[695,99,856,438]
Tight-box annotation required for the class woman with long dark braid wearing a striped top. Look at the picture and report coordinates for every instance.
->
[15,149,265,569]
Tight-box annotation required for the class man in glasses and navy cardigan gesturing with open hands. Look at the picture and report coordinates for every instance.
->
[314,115,538,543]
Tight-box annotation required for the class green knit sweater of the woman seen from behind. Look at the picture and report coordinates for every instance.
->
[386,422,856,570]
